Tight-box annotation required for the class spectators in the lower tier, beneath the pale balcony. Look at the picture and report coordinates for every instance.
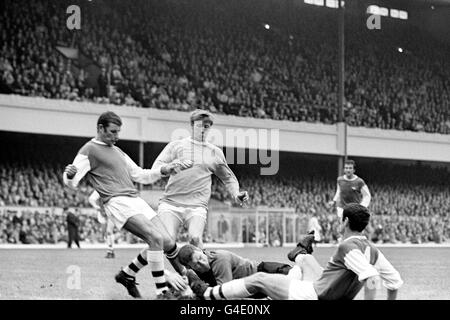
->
[0,153,450,245]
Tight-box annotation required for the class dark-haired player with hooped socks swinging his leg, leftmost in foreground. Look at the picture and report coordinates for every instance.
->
[63,111,192,298]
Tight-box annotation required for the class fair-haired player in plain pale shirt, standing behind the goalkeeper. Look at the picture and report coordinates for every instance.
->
[117,109,248,284]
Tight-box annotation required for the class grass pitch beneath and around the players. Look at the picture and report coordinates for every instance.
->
[0,247,450,300]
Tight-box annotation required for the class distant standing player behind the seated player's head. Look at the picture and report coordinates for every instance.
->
[329,160,371,219]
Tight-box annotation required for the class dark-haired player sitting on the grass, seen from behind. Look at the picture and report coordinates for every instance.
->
[190,203,403,300]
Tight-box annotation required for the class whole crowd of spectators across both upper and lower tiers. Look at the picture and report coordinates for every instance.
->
[0,0,450,243]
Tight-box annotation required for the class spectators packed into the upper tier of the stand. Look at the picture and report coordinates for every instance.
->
[0,0,450,134]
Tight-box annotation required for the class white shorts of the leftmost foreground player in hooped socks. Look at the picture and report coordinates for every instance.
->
[104,196,156,230]
